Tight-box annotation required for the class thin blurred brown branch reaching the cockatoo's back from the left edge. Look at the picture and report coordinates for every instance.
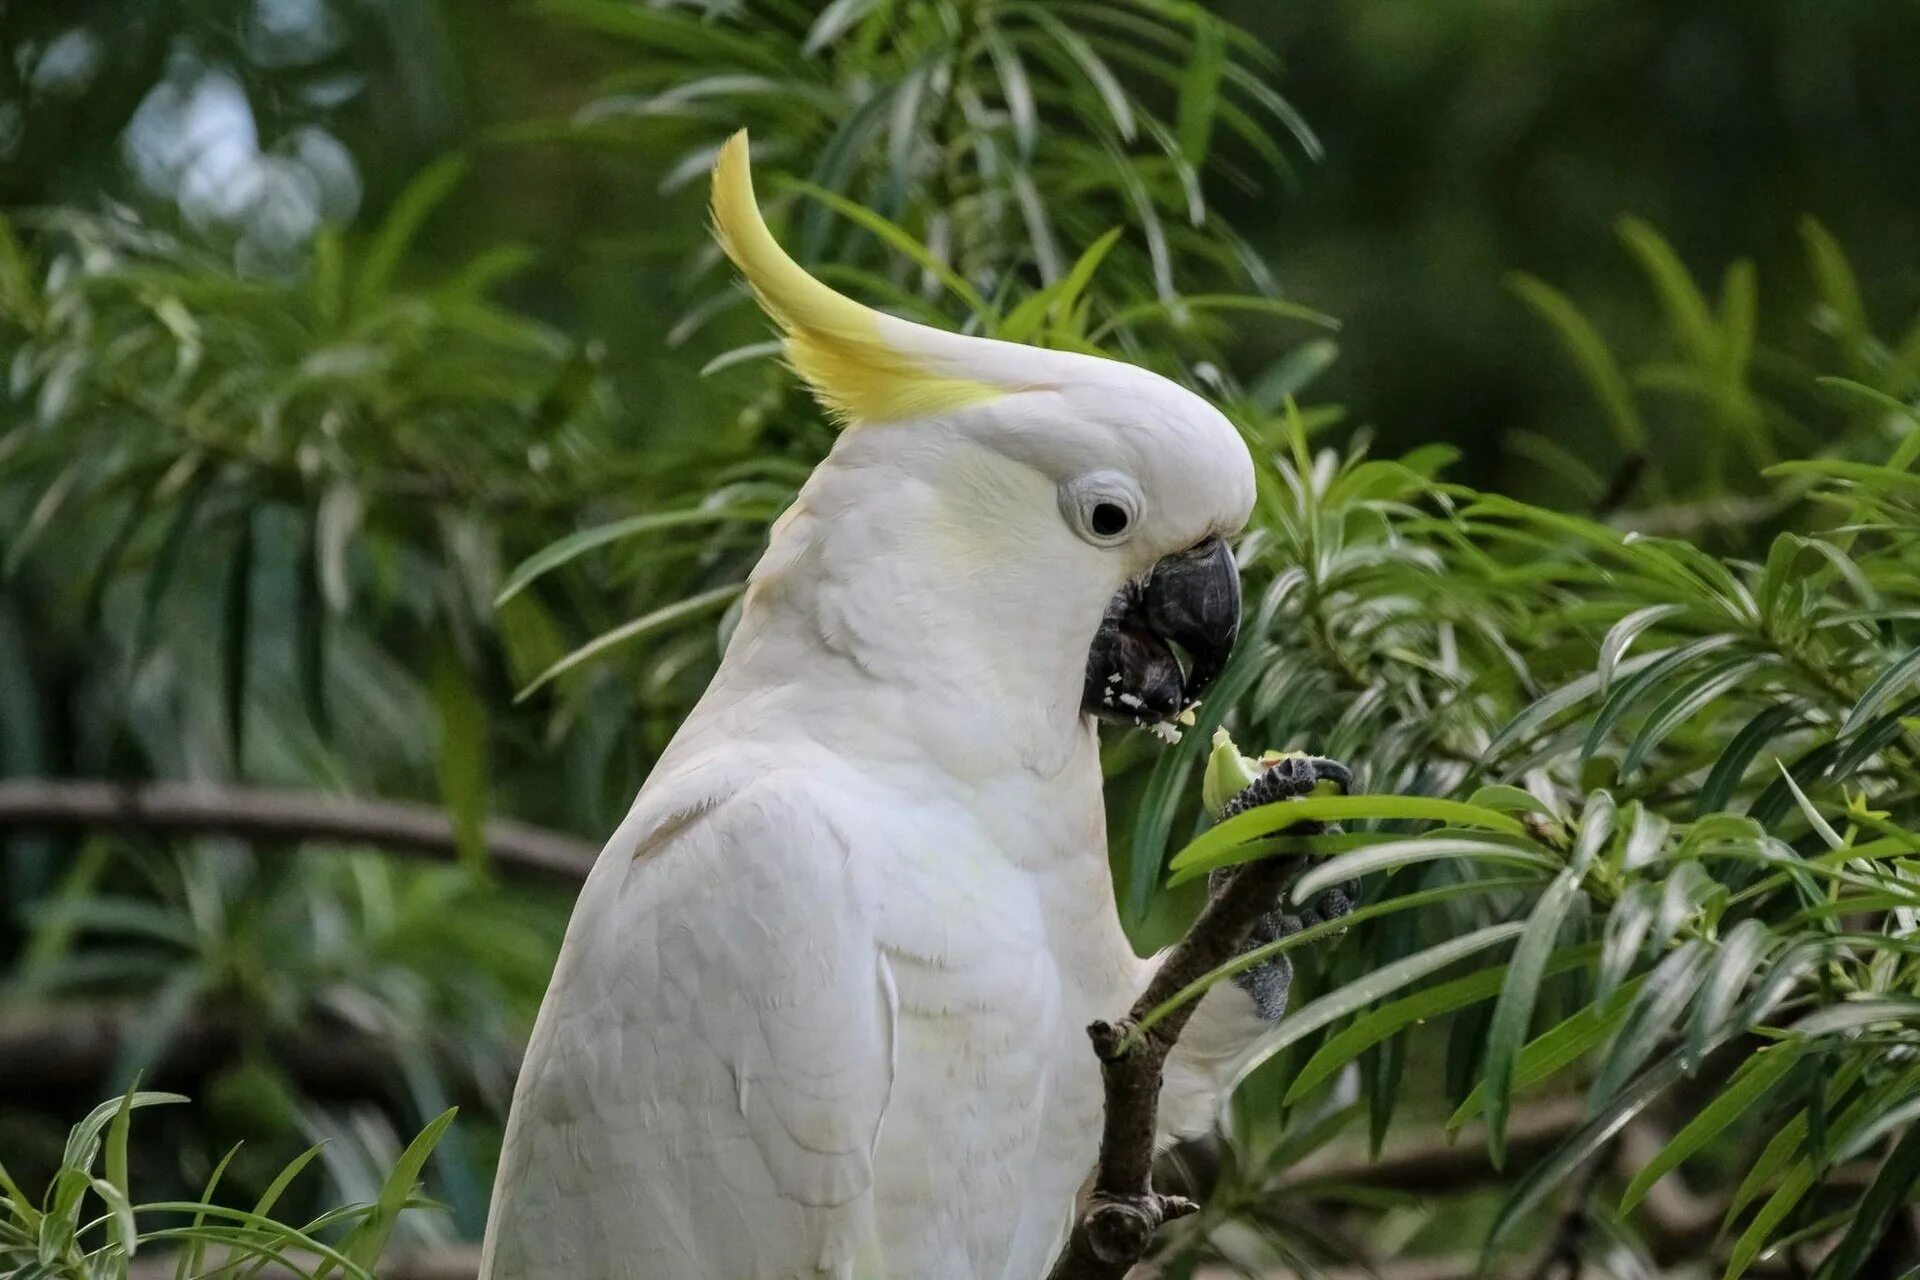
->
[0,779,599,883]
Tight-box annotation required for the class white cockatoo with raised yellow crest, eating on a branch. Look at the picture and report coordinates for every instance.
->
[480,134,1320,1280]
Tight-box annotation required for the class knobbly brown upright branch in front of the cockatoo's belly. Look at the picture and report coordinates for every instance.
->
[1048,844,1306,1280]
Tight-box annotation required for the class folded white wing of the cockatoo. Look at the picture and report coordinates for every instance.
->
[480,779,897,1280]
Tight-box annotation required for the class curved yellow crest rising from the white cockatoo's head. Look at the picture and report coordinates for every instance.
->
[712,129,1004,426]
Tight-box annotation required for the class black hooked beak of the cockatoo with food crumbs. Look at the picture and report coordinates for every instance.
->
[1081,537,1240,723]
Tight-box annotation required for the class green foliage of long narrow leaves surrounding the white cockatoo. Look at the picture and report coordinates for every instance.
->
[11,0,1920,1280]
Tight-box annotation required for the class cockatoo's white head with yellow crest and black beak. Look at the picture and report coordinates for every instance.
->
[712,132,1254,740]
